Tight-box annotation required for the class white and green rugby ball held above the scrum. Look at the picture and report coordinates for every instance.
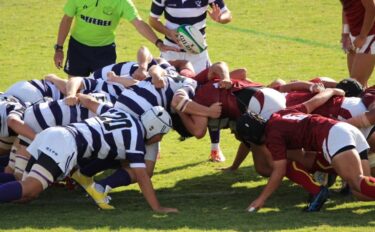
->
[177,24,207,54]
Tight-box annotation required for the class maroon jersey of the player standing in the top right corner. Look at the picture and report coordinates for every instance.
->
[341,0,375,36]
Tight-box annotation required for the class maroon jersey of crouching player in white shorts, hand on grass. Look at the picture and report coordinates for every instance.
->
[265,104,337,160]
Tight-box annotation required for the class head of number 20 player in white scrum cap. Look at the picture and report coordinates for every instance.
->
[141,106,172,139]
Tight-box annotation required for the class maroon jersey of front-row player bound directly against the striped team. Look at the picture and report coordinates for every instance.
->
[193,66,262,119]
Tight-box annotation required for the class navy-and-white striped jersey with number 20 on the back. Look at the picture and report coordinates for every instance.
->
[66,106,146,168]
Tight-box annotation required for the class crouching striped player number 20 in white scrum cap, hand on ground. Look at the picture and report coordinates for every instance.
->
[0,93,177,213]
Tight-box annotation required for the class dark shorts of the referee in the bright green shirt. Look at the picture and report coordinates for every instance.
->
[64,37,116,77]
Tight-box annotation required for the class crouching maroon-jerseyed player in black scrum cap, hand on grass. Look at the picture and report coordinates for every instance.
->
[237,104,375,211]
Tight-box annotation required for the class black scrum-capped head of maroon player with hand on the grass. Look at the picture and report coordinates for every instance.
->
[236,112,266,145]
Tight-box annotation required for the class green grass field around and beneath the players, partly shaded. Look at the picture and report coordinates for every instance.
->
[0,0,375,231]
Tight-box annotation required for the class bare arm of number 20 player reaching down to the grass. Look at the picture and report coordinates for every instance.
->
[132,168,178,213]
